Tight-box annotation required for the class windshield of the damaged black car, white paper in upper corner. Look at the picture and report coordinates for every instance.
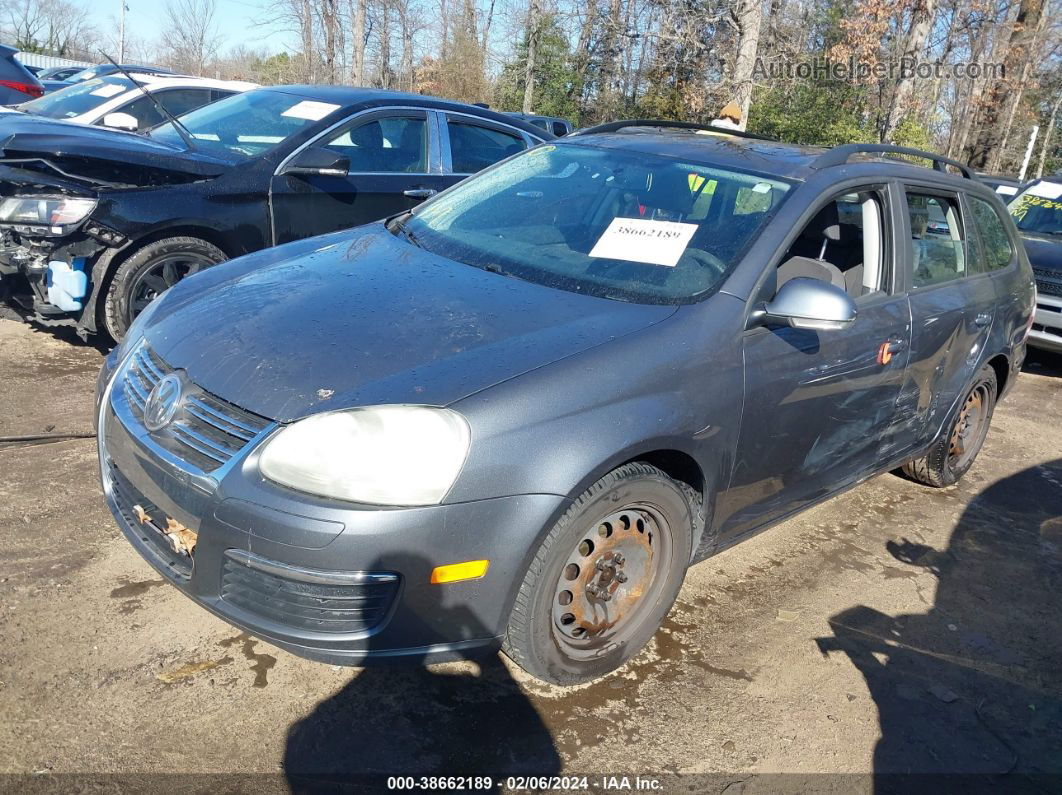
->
[149,89,340,158]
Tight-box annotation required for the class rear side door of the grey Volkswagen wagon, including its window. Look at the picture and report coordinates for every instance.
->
[901,184,996,448]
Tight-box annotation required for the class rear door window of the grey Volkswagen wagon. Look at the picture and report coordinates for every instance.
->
[907,192,966,288]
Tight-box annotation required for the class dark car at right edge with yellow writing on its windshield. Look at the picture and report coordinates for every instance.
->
[1010,175,1062,353]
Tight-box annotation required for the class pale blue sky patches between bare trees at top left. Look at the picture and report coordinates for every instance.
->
[117,0,291,52]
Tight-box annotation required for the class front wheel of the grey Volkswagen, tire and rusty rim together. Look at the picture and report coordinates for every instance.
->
[502,462,701,685]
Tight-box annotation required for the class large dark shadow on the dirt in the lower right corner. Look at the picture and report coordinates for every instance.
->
[817,459,1062,792]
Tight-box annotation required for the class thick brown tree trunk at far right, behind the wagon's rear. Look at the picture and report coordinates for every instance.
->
[969,0,1045,170]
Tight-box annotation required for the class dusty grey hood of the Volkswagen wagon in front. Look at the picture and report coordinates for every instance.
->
[145,224,675,421]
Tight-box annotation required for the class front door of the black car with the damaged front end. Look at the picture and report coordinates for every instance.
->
[270,109,457,244]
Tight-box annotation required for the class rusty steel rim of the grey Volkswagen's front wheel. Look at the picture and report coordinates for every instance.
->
[552,504,671,658]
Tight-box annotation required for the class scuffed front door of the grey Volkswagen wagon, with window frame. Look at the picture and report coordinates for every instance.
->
[717,186,911,542]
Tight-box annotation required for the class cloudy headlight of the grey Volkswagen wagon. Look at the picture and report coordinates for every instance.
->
[258,405,469,505]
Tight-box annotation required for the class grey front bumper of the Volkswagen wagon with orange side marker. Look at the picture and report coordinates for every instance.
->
[99,354,568,664]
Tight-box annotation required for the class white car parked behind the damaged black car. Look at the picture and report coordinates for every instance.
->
[5,73,258,132]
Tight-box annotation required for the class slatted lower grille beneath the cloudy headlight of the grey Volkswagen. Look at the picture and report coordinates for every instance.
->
[221,550,398,633]
